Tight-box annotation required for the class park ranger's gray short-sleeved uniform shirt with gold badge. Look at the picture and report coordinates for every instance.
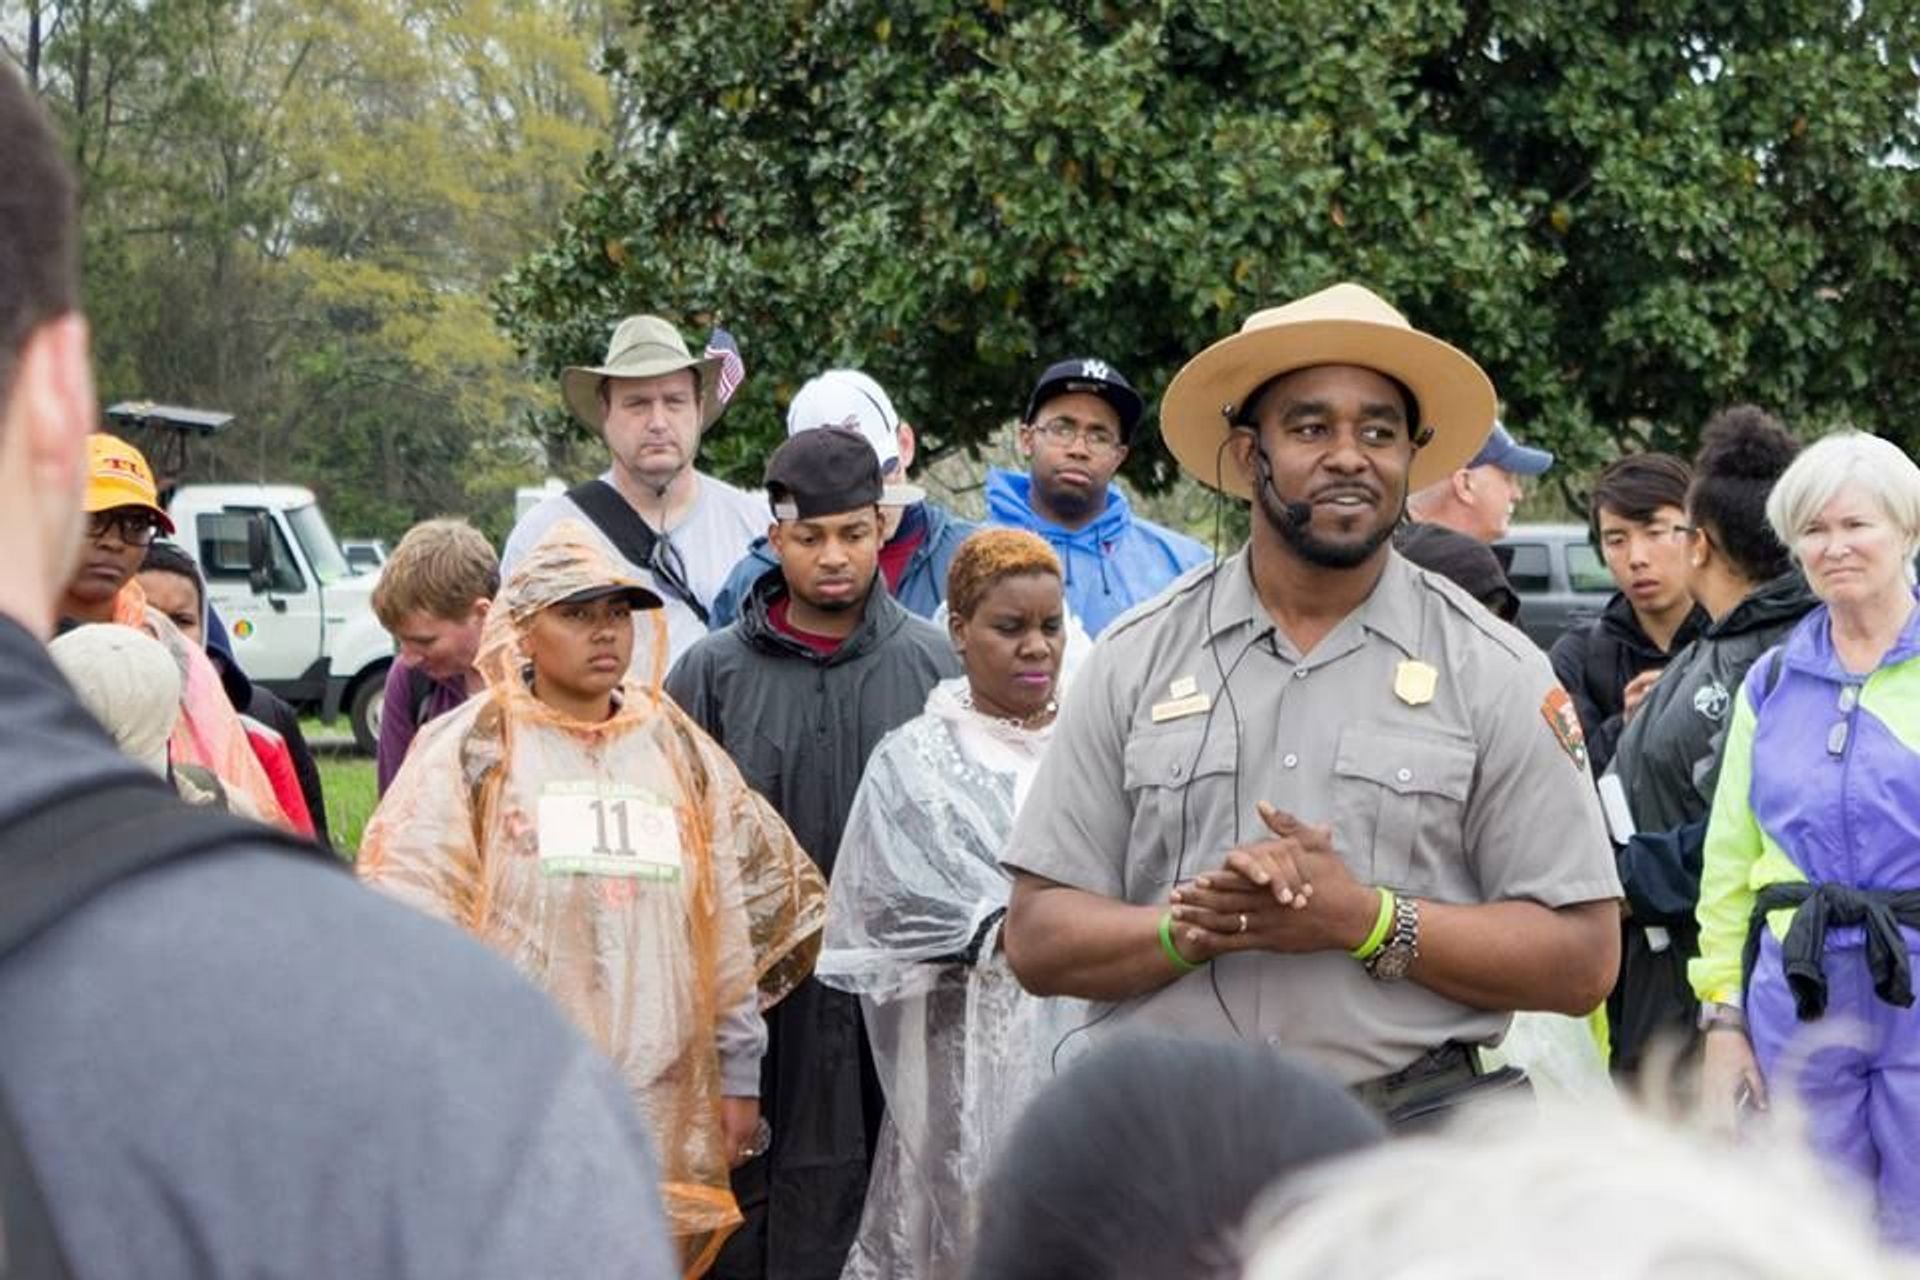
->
[1002,551,1620,1080]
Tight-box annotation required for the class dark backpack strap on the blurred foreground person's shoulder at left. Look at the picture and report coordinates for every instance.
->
[0,779,344,1280]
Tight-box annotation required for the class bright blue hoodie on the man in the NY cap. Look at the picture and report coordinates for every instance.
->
[987,468,1213,635]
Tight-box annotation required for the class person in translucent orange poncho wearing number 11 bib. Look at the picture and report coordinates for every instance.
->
[357,522,826,1276]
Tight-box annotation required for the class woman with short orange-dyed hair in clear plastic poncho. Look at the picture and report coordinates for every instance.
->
[818,530,1071,1280]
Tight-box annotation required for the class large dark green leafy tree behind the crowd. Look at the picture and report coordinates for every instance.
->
[495,0,1920,487]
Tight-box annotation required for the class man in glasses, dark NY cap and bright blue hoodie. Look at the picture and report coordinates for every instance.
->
[987,357,1213,635]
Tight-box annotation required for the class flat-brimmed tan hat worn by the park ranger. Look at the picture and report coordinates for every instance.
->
[1160,284,1500,499]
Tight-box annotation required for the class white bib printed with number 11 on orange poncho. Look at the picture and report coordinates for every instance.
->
[538,783,682,883]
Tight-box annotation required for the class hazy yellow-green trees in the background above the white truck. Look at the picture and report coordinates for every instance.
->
[13,0,611,537]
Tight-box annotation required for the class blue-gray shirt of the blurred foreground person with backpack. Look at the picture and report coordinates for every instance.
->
[0,620,680,1280]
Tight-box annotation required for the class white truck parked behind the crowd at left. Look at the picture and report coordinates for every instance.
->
[167,484,394,752]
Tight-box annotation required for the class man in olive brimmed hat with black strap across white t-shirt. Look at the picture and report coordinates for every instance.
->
[501,315,766,662]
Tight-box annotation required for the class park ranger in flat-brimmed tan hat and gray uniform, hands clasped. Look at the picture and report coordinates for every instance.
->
[1002,284,1620,1119]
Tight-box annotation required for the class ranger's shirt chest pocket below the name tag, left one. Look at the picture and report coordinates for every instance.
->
[1121,716,1252,902]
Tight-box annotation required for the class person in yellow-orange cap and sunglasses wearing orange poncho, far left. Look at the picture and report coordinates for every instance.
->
[60,434,291,831]
